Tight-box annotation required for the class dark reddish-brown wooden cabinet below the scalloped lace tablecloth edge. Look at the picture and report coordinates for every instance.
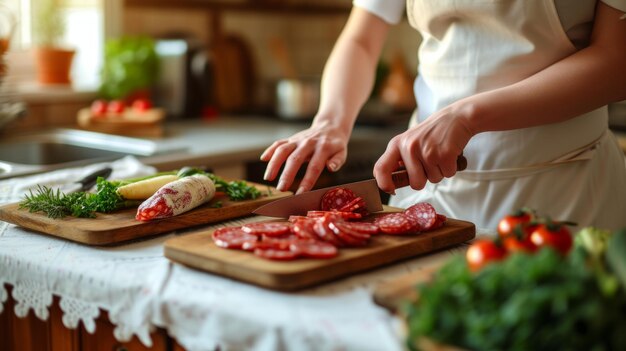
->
[0,287,179,351]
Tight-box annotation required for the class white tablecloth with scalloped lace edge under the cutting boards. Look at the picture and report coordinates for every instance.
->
[0,157,476,350]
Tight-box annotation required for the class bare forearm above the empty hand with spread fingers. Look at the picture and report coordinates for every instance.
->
[313,8,388,135]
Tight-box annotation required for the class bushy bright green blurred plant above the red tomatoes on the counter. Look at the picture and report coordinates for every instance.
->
[100,37,159,101]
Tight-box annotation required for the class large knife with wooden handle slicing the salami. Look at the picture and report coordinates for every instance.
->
[252,155,467,218]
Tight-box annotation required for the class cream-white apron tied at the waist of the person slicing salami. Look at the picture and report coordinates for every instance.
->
[390,0,626,230]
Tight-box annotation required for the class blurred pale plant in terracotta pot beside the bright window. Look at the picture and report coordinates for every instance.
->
[33,0,75,85]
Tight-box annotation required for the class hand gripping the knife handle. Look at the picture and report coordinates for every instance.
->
[374,103,475,193]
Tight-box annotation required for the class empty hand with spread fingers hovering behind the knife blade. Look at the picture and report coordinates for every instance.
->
[261,123,350,194]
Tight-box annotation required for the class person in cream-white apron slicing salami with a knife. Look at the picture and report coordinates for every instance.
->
[261,0,626,229]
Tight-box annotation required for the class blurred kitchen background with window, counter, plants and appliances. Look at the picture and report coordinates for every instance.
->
[0,0,626,191]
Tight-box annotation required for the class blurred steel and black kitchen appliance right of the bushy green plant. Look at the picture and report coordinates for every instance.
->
[154,34,212,119]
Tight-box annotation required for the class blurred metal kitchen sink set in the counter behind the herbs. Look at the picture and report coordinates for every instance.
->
[0,129,173,179]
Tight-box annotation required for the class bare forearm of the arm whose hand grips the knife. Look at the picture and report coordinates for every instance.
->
[459,3,626,133]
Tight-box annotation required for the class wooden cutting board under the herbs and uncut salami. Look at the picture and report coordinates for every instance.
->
[0,182,291,245]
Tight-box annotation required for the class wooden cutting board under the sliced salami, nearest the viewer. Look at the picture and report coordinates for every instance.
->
[164,207,476,290]
